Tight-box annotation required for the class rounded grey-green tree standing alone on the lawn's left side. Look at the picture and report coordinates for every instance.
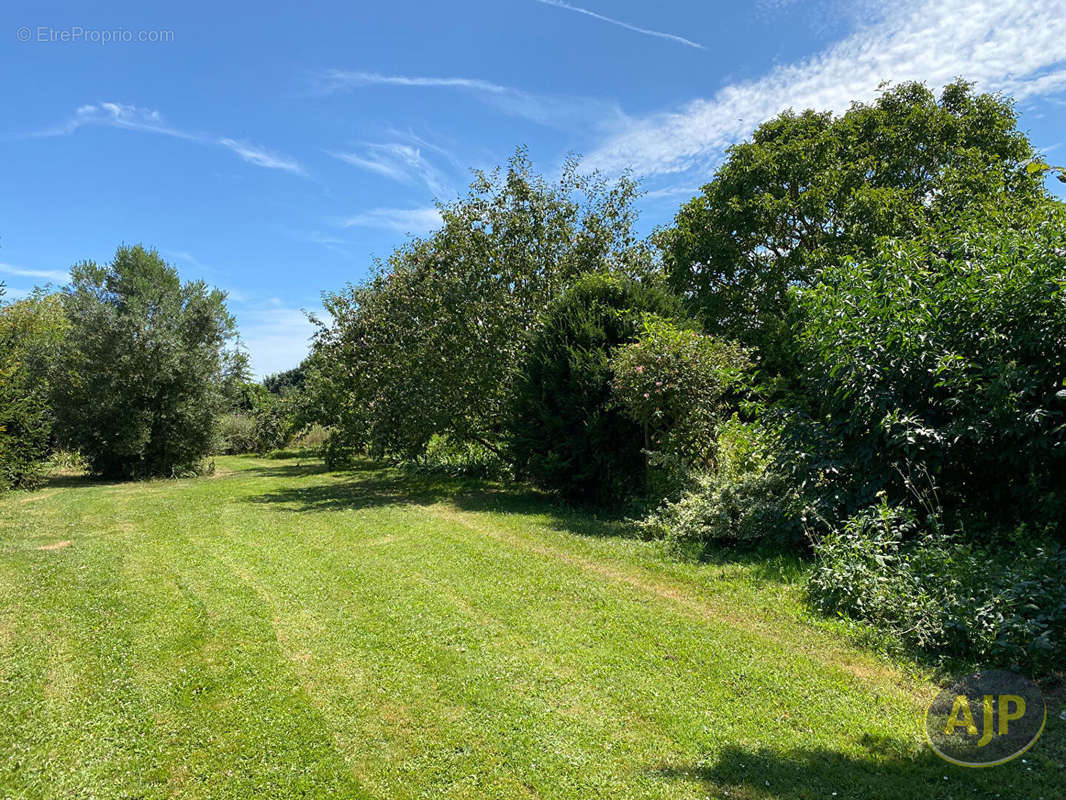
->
[53,245,245,478]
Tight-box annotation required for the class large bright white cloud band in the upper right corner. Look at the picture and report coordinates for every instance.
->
[584,0,1066,175]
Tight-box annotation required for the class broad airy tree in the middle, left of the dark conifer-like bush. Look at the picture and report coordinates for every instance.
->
[308,150,650,457]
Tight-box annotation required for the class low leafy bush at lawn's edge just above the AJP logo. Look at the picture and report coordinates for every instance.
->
[809,500,1066,675]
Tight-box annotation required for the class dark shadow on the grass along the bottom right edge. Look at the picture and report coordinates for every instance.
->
[651,735,1060,800]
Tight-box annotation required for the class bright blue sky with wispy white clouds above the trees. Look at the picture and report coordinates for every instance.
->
[0,0,1066,374]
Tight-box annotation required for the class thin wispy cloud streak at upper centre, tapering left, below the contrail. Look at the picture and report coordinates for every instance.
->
[316,69,626,130]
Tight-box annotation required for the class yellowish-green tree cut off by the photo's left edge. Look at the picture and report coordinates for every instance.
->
[0,291,67,490]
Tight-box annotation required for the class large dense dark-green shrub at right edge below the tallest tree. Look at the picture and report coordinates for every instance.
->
[791,203,1066,532]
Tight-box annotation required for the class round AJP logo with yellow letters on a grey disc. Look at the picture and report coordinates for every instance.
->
[925,670,1048,767]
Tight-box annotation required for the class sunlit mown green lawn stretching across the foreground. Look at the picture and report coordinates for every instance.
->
[0,457,1066,800]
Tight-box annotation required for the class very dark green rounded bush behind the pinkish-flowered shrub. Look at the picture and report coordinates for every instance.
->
[510,274,680,506]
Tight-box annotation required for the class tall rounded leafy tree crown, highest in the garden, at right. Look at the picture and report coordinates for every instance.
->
[658,81,1045,374]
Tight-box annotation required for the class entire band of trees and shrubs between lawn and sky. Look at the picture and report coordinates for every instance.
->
[0,81,1066,673]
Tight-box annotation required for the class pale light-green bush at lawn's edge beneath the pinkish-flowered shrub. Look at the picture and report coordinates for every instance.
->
[641,417,802,555]
